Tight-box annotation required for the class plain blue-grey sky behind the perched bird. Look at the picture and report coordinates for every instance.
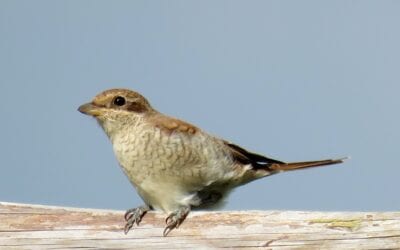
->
[0,0,400,211]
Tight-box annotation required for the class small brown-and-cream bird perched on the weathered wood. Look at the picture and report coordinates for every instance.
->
[78,88,344,236]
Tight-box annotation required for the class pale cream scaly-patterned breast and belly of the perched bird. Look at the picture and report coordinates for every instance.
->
[113,126,260,212]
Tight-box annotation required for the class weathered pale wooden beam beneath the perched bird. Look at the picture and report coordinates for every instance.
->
[0,202,400,249]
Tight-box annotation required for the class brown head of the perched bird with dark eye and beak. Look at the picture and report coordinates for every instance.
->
[78,89,154,136]
